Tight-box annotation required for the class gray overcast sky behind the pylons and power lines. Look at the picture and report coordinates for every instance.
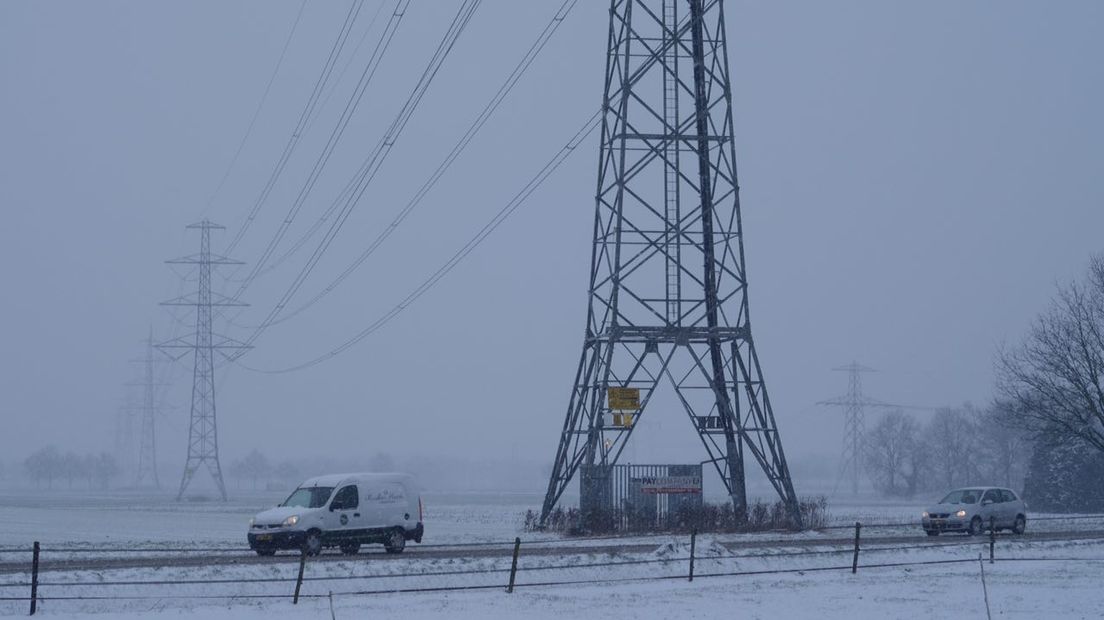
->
[0,0,1104,478]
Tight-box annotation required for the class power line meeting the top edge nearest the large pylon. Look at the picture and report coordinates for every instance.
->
[248,0,577,325]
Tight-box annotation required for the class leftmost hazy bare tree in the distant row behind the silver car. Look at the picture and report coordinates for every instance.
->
[866,410,919,494]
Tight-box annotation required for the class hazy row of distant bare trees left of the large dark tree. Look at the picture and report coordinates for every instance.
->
[864,405,1031,498]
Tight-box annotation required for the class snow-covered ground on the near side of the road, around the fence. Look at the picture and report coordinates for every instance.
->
[0,541,1104,620]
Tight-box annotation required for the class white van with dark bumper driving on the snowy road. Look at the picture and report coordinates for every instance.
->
[248,473,425,555]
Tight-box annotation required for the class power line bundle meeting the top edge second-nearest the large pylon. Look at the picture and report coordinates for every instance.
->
[232,0,482,344]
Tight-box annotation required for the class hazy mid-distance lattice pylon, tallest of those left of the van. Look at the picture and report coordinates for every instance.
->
[157,220,248,501]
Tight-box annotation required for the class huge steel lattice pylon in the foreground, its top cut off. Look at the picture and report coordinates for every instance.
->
[541,0,800,524]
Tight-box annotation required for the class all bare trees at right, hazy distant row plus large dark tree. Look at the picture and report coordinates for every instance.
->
[866,255,1104,511]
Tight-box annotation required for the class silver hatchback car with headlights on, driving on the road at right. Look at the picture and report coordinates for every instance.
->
[921,487,1028,536]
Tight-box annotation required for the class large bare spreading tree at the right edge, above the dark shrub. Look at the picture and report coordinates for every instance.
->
[997,256,1104,451]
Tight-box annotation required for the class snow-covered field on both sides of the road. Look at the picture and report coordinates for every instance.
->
[0,492,1104,620]
